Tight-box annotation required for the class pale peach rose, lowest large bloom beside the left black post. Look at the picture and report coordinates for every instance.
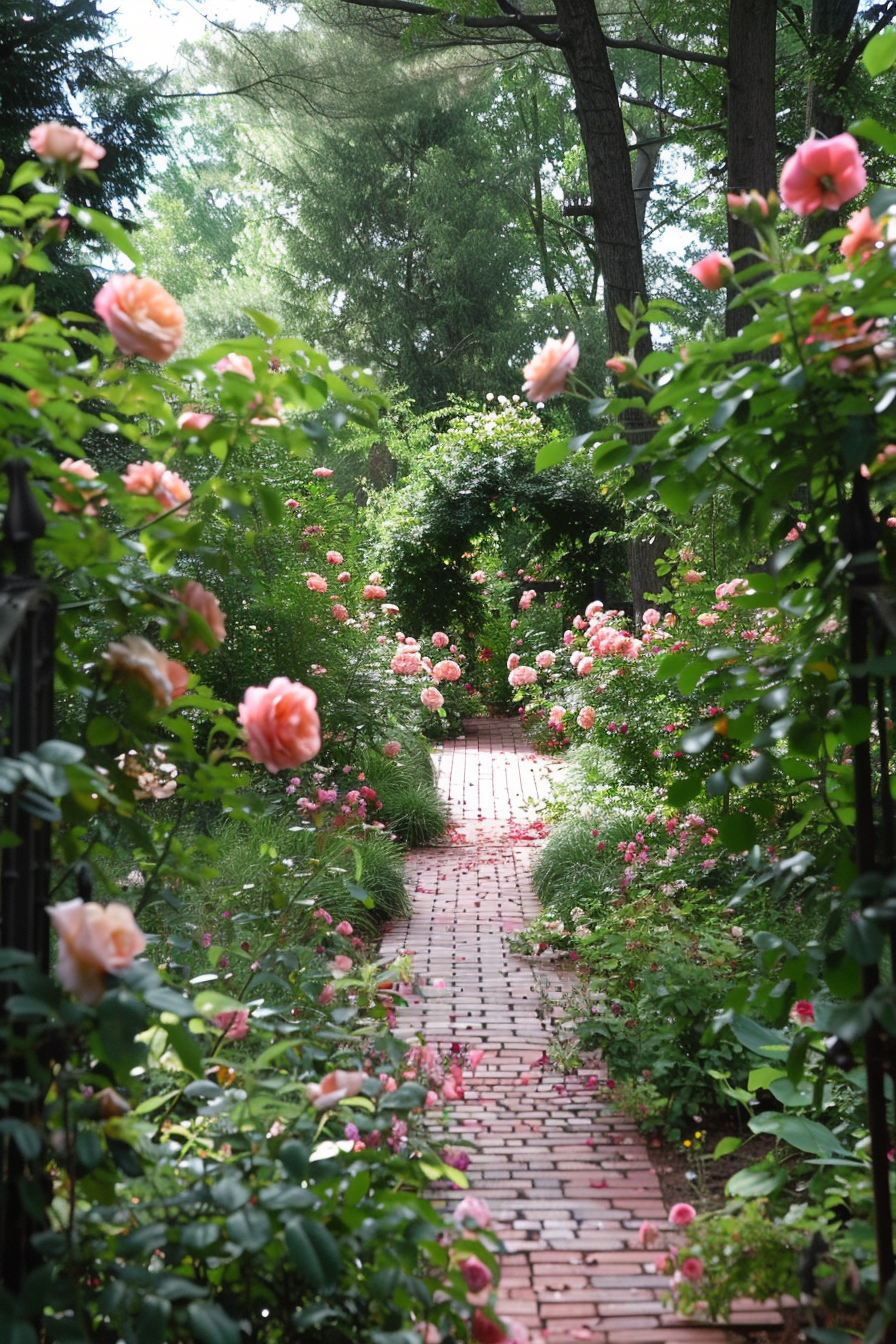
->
[47,896,146,1004]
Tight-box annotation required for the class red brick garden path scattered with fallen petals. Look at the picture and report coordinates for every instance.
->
[383,719,780,1344]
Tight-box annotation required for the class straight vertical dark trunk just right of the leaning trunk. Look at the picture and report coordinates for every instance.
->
[725,0,776,336]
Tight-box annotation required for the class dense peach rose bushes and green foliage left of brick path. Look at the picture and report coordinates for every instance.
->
[0,133,531,1344]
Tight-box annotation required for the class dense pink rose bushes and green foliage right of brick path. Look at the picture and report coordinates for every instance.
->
[510,60,896,1344]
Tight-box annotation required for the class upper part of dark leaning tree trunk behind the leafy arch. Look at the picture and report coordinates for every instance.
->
[556,0,650,359]
